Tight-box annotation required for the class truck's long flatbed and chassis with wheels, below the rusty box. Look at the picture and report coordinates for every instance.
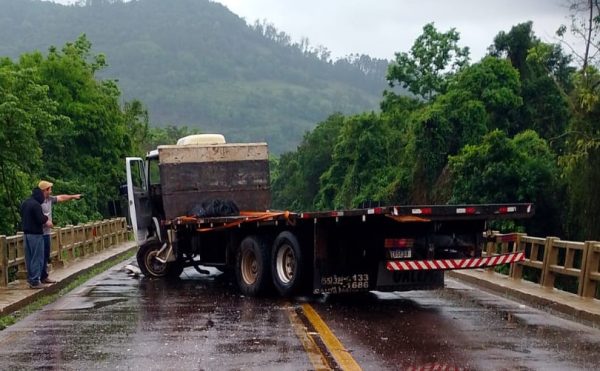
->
[138,204,533,296]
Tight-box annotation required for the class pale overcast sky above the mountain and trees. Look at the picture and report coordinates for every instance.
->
[47,0,570,62]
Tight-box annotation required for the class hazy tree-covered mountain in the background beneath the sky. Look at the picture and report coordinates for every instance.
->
[0,0,387,153]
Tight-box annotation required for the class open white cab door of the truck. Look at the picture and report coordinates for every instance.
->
[125,157,152,245]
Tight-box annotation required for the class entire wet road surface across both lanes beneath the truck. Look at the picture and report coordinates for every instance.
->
[0,258,600,370]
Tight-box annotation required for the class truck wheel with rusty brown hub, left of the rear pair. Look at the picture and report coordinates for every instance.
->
[235,236,271,296]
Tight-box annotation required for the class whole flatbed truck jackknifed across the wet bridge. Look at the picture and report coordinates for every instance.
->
[126,134,534,296]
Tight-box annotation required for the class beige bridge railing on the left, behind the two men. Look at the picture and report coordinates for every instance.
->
[0,218,129,287]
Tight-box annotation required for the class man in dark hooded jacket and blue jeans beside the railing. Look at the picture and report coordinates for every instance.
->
[21,188,48,289]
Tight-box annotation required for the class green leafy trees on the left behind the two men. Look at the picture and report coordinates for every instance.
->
[0,36,148,234]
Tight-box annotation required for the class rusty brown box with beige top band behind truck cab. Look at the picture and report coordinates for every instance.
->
[158,143,271,220]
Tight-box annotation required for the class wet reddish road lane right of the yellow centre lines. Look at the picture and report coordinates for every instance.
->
[314,280,600,370]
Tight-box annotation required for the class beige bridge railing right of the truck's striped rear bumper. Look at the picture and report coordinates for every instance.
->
[484,233,600,298]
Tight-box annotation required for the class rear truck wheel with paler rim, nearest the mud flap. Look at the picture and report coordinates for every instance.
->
[271,231,305,296]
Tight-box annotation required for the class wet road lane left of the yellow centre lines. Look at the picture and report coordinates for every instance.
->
[0,264,313,370]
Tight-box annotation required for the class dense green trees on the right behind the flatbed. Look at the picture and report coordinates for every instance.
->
[273,8,600,239]
